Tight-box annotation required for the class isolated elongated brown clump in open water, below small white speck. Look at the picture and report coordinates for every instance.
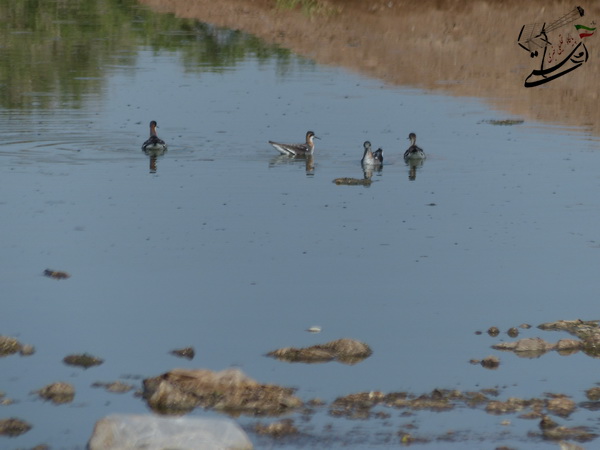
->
[267,339,373,364]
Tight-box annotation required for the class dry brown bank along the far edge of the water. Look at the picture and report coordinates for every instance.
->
[140,0,600,135]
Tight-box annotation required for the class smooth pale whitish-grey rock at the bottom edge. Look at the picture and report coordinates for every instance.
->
[88,414,253,450]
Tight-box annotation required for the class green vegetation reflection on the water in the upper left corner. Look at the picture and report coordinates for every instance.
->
[0,0,298,110]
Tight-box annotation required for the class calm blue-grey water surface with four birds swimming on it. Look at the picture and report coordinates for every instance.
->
[0,1,600,449]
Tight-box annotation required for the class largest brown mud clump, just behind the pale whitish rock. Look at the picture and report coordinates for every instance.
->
[144,369,302,415]
